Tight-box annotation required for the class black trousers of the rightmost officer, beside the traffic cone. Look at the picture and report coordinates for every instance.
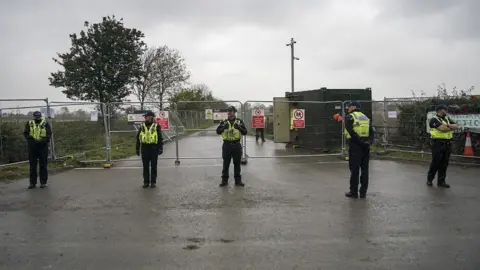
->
[427,140,452,184]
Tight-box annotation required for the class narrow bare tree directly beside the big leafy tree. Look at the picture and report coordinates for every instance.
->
[132,48,158,110]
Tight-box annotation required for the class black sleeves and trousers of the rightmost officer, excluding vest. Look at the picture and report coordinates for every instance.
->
[427,115,456,188]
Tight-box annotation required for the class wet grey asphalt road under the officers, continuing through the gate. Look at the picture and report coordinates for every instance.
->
[0,130,480,270]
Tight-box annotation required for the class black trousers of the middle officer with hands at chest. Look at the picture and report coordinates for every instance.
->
[222,141,243,182]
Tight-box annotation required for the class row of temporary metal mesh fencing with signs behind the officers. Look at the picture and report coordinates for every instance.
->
[0,97,480,167]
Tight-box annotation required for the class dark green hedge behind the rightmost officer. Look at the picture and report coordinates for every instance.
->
[396,85,480,154]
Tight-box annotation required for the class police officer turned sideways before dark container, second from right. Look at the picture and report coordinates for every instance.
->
[345,101,374,198]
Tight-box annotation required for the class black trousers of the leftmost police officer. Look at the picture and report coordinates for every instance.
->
[28,142,48,185]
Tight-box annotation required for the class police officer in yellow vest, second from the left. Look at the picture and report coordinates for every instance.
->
[136,111,163,188]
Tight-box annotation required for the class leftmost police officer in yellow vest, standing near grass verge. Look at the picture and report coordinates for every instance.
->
[23,111,52,189]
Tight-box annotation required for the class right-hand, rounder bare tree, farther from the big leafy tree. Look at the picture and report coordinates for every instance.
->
[147,45,190,110]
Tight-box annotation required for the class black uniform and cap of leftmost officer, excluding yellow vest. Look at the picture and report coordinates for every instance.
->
[23,112,52,189]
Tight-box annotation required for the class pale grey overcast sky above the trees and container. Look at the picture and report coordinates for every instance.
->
[0,0,480,104]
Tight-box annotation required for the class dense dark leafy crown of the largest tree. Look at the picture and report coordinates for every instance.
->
[49,16,145,103]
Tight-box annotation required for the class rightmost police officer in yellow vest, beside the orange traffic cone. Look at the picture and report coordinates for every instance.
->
[427,105,458,188]
